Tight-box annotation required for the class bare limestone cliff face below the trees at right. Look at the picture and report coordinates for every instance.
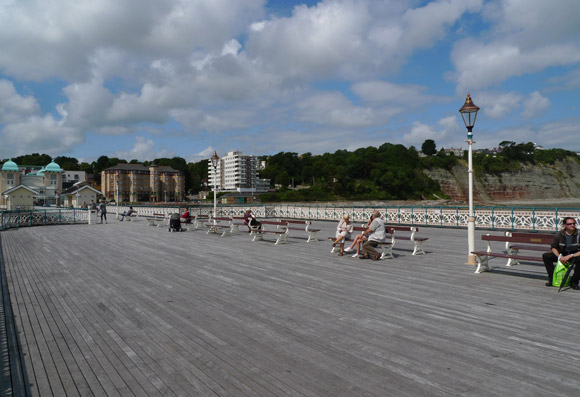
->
[424,157,580,202]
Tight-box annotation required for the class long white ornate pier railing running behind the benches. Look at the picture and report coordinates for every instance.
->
[114,204,580,232]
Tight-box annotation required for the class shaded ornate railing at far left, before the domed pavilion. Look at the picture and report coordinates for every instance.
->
[0,208,89,230]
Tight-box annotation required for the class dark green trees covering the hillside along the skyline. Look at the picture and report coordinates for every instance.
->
[4,139,578,202]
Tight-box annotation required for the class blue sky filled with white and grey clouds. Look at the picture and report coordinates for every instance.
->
[0,0,580,162]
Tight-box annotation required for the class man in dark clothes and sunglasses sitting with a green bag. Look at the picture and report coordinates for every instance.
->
[542,216,580,290]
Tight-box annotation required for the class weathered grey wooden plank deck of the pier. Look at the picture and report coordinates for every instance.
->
[0,219,580,396]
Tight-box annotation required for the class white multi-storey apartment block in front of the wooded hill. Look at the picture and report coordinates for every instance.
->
[208,151,270,193]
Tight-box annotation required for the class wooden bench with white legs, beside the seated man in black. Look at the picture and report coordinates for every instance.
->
[471,233,554,273]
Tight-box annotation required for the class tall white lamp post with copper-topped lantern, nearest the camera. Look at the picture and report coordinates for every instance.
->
[459,93,479,265]
